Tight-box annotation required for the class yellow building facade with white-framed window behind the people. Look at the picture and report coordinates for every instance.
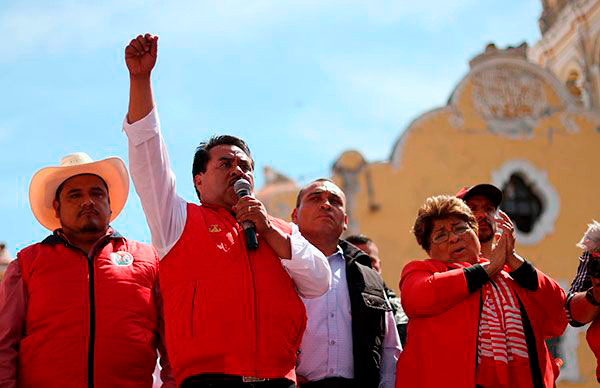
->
[258,1,600,387]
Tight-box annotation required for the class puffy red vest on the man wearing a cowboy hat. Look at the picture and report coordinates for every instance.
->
[17,236,158,388]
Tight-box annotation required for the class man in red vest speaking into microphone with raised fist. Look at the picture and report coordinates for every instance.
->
[124,34,331,388]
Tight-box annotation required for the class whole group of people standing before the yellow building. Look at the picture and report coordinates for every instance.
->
[0,34,600,388]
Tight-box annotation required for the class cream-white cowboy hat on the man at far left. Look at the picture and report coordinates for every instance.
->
[29,152,129,230]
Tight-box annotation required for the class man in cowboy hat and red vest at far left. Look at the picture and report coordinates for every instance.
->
[0,152,174,387]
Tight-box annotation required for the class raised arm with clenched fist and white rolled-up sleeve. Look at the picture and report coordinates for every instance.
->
[123,34,187,259]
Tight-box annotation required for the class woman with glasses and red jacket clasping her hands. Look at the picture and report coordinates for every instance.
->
[396,195,566,388]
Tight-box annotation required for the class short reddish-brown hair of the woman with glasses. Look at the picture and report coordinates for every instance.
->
[412,195,479,252]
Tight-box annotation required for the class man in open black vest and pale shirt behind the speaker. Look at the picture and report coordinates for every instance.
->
[292,179,401,388]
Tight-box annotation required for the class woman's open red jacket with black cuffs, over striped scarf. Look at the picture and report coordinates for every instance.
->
[396,260,567,388]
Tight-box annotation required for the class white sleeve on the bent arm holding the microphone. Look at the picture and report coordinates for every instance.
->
[281,223,331,298]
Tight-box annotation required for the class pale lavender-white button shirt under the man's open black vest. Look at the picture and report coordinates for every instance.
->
[296,247,402,388]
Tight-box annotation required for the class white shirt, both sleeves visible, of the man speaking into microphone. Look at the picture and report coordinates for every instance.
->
[123,108,331,298]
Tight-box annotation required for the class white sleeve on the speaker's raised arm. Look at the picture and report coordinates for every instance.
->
[123,107,187,259]
